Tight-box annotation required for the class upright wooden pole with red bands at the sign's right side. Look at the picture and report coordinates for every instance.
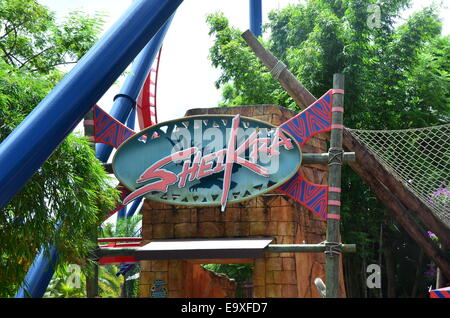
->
[325,74,344,298]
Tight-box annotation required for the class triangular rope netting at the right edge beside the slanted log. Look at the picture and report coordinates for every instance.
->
[349,124,450,227]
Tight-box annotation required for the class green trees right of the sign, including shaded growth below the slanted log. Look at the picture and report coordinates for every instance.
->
[207,0,450,297]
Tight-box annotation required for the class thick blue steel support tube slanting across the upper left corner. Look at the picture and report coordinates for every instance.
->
[0,0,182,210]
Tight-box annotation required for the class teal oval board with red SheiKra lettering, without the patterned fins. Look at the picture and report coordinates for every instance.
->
[112,115,301,209]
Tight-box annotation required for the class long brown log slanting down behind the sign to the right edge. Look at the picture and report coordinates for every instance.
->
[242,31,450,278]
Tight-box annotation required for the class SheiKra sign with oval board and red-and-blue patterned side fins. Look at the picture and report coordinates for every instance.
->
[93,89,343,220]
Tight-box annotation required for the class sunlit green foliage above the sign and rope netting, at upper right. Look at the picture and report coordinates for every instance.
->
[207,0,450,129]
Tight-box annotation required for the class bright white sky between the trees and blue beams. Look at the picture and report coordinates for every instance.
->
[38,0,450,126]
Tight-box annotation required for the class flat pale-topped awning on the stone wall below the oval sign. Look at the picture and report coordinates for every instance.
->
[134,237,274,261]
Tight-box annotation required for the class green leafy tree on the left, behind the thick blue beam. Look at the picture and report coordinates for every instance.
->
[0,0,118,297]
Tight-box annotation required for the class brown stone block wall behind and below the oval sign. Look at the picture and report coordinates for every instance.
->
[140,105,345,298]
